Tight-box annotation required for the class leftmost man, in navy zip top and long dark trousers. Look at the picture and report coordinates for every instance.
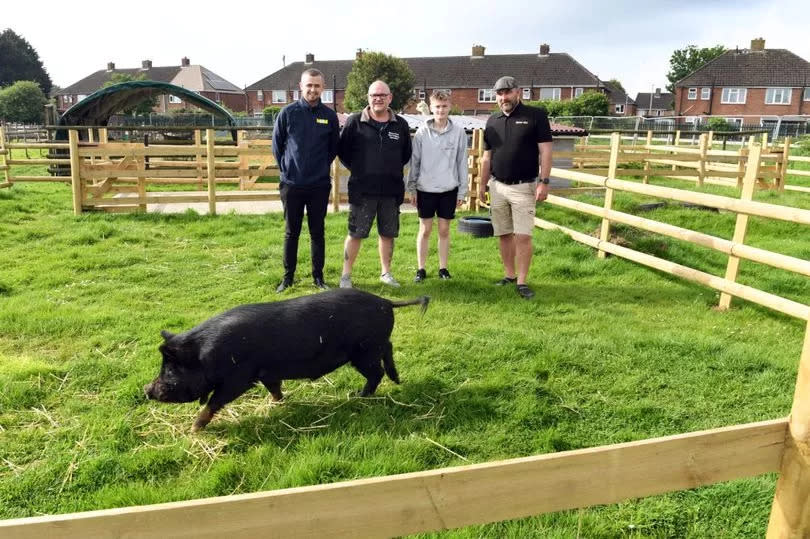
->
[273,69,340,293]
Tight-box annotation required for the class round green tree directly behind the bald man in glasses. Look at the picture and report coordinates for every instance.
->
[343,52,414,111]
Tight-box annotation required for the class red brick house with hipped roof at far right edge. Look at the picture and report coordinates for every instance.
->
[675,38,810,125]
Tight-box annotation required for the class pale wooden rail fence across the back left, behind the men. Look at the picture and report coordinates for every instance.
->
[0,128,482,215]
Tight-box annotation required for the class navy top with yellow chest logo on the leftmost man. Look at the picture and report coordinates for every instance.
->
[273,98,340,188]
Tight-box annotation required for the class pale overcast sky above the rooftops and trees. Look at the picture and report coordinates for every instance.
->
[6,0,810,97]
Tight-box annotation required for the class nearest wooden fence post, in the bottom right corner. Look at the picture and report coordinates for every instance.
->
[767,323,810,539]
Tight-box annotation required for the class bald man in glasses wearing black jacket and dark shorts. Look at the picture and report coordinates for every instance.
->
[338,80,411,288]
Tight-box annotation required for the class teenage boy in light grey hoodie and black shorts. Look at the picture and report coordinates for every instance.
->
[407,90,467,283]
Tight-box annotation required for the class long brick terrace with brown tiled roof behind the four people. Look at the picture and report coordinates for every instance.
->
[245,44,608,115]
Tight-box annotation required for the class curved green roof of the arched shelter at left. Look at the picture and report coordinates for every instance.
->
[56,80,236,140]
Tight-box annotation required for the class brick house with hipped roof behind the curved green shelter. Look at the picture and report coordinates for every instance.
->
[54,58,245,114]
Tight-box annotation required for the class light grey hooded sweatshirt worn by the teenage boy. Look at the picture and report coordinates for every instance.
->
[406,118,467,200]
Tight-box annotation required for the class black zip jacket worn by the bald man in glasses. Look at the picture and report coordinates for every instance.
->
[338,107,411,204]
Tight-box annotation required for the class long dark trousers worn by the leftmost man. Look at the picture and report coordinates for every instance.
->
[279,183,331,279]
